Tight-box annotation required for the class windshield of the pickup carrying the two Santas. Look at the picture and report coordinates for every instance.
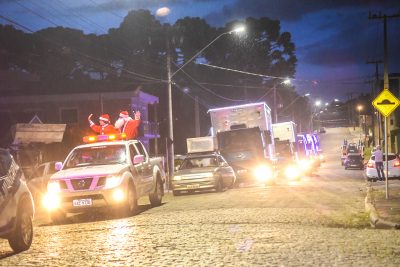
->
[64,145,127,169]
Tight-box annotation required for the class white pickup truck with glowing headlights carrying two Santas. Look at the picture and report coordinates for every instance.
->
[42,136,165,223]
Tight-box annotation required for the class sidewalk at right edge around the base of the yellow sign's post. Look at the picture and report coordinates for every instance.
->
[365,180,400,229]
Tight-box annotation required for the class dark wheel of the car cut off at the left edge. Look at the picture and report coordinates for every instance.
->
[8,200,33,253]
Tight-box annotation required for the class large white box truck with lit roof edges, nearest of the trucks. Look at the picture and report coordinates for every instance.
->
[208,102,275,182]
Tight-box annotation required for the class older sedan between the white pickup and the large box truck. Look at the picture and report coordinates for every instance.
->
[172,153,236,195]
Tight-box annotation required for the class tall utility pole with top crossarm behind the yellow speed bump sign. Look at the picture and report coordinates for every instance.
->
[368,13,400,199]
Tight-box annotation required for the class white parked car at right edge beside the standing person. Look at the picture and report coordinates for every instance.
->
[365,153,400,182]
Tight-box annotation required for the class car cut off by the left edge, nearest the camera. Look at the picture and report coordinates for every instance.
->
[0,148,35,252]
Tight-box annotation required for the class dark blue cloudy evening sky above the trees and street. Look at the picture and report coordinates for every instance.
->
[0,0,400,101]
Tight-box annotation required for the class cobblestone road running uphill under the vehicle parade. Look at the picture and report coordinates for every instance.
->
[0,129,400,266]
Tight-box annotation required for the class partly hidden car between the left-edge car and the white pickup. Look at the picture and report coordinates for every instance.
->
[27,161,56,207]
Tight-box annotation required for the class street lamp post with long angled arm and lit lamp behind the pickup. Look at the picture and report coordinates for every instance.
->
[167,26,245,186]
